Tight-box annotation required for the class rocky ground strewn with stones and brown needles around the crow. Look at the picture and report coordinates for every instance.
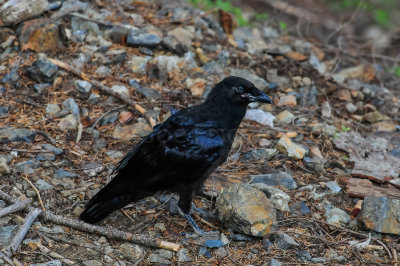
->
[0,0,400,266]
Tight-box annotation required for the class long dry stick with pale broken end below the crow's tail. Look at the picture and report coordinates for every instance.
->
[0,190,180,251]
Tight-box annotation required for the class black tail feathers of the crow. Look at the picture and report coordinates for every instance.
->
[79,186,132,224]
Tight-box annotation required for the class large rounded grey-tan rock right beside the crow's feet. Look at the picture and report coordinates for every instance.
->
[217,184,276,237]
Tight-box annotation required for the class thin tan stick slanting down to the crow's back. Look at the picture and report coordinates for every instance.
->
[49,58,156,127]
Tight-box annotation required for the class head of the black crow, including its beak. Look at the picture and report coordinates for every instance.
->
[208,76,272,105]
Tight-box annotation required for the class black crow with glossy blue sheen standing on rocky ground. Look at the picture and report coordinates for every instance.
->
[79,77,271,234]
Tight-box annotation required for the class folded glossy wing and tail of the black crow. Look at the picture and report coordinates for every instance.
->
[80,113,230,223]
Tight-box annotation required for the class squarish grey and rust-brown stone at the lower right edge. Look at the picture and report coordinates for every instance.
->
[357,195,400,235]
